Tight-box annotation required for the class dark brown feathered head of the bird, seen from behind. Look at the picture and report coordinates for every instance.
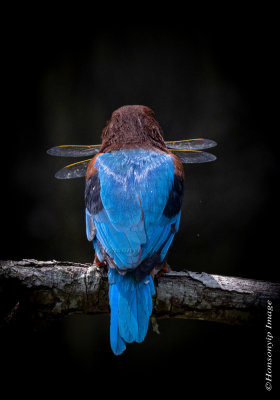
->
[100,105,168,153]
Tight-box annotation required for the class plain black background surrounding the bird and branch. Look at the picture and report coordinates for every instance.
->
[1,7,279,398]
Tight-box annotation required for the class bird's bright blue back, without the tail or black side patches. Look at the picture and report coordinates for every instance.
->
[89,149,179,271]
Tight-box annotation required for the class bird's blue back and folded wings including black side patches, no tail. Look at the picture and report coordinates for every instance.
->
[85,149,183,277]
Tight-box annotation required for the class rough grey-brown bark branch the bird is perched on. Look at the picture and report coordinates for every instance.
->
[0,259,280,324]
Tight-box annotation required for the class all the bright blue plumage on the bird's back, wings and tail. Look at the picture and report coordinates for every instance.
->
[86,149,182,354]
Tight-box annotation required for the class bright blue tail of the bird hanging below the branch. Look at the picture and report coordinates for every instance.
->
[109,268,155,355]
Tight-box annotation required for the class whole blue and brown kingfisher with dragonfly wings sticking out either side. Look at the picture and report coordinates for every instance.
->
[48,105,216,355]
